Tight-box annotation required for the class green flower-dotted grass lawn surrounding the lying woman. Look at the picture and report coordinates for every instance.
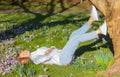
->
[0,13,118,77]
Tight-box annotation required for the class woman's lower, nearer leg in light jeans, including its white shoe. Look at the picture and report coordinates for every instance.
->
[59,22,107,65]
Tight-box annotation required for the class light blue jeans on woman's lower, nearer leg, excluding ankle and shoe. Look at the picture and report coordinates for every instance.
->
[59,31,98,65]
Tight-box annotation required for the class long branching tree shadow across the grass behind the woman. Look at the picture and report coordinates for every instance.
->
[0,0,87,41]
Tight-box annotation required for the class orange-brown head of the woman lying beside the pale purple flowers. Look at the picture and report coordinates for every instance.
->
[17,50,30,64]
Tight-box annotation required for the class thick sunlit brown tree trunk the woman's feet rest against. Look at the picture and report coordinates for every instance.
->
[89,0,120,75]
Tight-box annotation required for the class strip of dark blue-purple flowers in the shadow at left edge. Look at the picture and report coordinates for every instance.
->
[0,25,38,41]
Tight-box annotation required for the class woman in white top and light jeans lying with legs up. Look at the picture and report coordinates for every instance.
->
[17,6,107,65]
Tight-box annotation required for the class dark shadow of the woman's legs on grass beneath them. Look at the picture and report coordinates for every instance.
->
[75,35,114,58]
